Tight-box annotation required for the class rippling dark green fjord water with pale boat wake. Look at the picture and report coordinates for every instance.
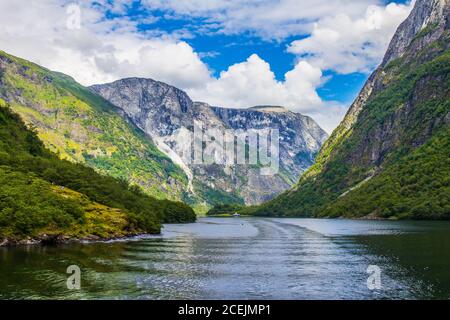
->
[0,218,450,299]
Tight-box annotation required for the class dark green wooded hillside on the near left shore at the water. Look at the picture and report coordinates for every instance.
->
[0,104,196,239]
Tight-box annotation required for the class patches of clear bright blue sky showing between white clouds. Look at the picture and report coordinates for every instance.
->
[122,0,409,104]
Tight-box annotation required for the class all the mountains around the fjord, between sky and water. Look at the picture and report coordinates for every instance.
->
[0,0,450,244]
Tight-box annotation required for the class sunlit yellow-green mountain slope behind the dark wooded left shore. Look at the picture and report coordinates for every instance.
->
[0,51,188,200]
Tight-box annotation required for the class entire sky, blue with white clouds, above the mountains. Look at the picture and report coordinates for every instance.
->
[0,0,414,133]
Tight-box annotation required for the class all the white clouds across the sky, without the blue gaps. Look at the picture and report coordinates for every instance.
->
[0,0,410,130]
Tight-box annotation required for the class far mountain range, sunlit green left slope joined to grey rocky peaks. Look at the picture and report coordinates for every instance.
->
[0,51,326,211]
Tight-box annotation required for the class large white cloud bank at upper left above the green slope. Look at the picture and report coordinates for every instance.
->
[0,0,210,88]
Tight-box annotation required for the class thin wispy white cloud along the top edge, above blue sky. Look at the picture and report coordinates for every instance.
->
[142,0,379,39]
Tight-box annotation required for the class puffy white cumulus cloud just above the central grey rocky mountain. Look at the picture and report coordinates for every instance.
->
[191,54,323,112]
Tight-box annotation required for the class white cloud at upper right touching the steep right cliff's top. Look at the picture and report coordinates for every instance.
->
[288,3,412,74]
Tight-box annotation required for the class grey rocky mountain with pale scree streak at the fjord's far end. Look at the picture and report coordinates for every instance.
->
[91,78,327,206]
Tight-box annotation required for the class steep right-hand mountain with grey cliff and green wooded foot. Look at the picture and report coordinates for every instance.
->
[247,0,450,219]
